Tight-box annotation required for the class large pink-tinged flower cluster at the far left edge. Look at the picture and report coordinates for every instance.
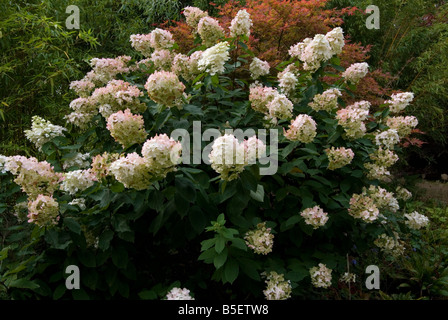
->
[5,156,62,199]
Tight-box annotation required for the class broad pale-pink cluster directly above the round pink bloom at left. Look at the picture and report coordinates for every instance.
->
[91,80,146,119]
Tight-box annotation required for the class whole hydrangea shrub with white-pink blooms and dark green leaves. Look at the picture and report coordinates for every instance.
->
[0,7,428,300]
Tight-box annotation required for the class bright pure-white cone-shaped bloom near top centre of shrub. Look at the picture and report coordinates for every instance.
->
[198,41,230,76]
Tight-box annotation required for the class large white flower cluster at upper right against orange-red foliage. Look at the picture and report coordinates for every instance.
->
[289,27,344,72]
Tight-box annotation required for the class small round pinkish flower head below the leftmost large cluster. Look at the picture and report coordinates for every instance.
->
[28,194,59,227]
